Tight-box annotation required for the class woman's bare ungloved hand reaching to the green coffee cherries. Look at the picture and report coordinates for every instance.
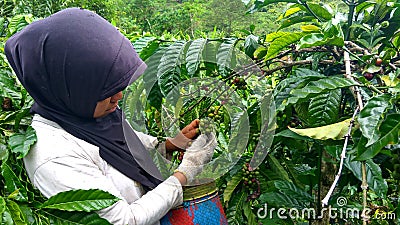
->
[165,119,200,152]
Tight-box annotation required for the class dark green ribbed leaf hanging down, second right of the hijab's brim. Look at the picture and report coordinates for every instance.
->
[157,41,186,96]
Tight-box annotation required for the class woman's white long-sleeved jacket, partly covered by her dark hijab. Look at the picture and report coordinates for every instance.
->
[24,115,183,225]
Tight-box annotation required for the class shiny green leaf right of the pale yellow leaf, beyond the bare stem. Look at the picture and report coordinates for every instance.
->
[357,94,392,147]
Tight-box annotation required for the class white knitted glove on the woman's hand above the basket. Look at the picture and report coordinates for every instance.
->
[176,133,217,184]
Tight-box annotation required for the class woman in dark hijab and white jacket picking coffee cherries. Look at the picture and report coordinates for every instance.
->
[5,8,216,224]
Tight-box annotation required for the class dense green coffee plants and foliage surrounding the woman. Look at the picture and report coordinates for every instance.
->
[0,0,400,224]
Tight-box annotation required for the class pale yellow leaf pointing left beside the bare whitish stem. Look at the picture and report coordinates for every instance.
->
[289,118,351,140]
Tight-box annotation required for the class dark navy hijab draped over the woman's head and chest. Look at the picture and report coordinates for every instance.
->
[5,8,161,188]
